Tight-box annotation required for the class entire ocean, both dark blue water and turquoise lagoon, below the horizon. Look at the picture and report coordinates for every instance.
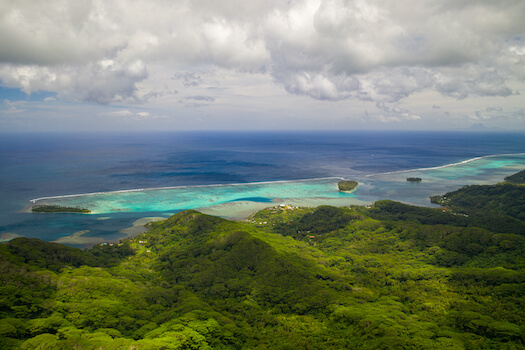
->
[0,131,525,247]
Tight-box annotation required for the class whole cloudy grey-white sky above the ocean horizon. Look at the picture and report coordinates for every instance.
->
[0,0,525,132]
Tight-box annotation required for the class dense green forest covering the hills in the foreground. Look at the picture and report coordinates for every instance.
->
[0,174,525,350]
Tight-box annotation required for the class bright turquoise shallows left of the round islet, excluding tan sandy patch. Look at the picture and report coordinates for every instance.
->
[31,178,355,214]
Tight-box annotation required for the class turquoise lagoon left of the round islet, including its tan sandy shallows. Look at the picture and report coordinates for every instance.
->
[32,178,360,219]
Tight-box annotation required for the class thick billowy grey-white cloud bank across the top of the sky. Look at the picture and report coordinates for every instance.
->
[0,0,525,104]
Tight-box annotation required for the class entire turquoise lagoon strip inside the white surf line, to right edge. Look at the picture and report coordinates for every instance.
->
[28,153,525,219]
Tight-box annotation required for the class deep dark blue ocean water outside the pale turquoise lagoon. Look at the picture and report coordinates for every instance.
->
[0,131,525,245]
